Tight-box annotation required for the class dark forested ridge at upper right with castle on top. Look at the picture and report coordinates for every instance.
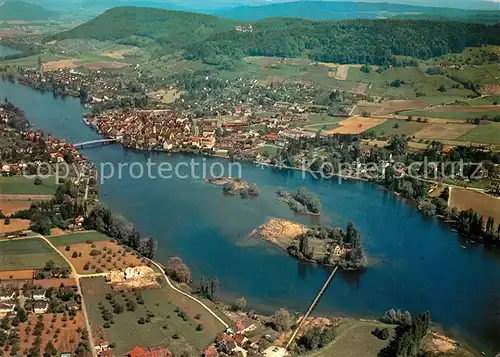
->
[186,19,500,64]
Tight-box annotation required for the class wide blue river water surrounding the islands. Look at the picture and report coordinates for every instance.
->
[0,80,500,353]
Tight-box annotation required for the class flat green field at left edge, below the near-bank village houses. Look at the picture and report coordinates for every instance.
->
[0,176,58,195]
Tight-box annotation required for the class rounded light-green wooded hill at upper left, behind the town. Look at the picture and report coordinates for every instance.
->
[52,6,234,51]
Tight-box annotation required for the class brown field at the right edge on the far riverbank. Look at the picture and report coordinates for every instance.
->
[450,187,500,223]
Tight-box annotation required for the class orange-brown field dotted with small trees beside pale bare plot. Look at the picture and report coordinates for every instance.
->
[54,238,144,274]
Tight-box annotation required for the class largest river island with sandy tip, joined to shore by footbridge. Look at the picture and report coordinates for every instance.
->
[250,218,367,270]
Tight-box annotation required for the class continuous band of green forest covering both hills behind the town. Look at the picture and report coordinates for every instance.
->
[51,7,500,65]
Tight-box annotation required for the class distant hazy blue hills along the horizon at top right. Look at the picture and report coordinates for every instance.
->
[215,1,499,21]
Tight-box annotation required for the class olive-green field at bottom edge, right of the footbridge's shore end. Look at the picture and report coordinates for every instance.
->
[307,320,394,357]
